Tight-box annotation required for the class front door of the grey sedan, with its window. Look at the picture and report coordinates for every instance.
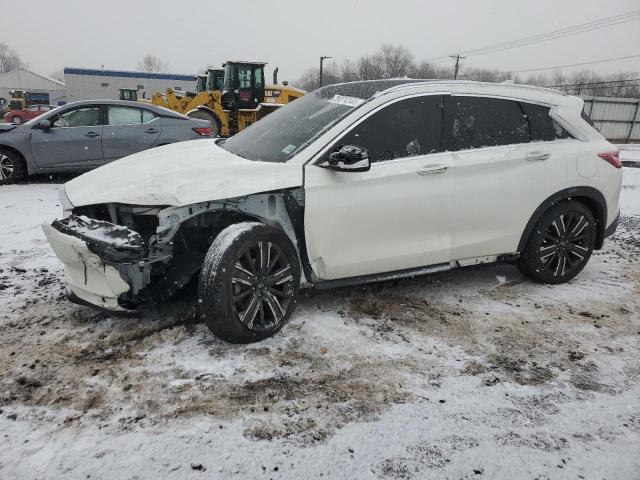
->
[31,105,103,169]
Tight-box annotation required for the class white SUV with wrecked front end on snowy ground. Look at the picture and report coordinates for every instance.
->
[44,79,622,342]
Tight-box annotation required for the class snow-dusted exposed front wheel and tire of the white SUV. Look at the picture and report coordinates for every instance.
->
[198,222,300,343]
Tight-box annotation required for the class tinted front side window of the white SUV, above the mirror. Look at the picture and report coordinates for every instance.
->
[339,95,442,162]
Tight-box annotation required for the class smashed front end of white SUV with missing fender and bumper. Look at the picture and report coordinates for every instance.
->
[43,189,304,313]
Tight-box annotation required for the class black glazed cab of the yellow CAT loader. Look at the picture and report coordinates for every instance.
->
[222,62,266,110]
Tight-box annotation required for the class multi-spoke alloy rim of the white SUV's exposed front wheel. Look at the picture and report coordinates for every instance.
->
[231,241,294,331]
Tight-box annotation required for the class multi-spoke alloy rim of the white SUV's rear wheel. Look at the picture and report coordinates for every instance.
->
[539,212,593,277]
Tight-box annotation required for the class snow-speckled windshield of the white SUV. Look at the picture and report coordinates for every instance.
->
[221,91,364,162]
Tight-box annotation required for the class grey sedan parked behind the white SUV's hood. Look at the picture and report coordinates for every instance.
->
[0,100,211,185]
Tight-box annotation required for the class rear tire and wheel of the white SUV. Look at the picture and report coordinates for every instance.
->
[518,200,596,284]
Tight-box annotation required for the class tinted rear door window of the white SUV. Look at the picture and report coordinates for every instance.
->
[445,97,531,151]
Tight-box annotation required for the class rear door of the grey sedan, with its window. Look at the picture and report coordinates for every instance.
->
[102,105,162,163]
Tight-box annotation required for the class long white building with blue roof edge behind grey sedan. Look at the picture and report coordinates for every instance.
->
[64,68,196,102]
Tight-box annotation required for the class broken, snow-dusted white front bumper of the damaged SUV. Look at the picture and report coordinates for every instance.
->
[42,215,159,313]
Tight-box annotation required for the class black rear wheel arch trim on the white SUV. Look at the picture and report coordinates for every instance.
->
[517,187,607,253]
